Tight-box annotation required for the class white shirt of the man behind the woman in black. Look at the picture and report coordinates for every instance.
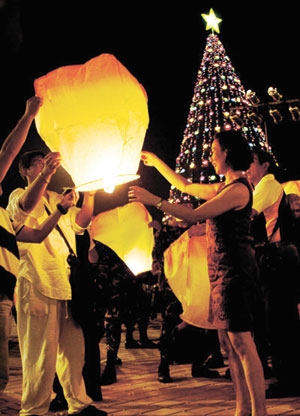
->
[252,174,283,242]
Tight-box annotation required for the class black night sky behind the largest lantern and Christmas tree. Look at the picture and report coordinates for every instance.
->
[0,0,300,218]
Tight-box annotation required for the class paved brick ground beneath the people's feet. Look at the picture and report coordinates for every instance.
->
[0,319,300,416]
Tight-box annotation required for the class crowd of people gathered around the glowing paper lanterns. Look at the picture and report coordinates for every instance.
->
[0,97,300,416]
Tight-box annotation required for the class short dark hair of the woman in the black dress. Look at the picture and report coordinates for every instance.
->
[214,130,253,171]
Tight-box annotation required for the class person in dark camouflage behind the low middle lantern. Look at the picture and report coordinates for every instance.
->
[88,240,139,385]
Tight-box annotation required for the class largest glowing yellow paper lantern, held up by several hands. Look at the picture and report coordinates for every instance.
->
[34,54,149,191]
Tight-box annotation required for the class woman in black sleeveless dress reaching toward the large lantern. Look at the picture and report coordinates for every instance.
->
[129,130,267,416]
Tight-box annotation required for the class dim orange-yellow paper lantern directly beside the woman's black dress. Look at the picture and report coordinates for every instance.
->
[164,231,214,329]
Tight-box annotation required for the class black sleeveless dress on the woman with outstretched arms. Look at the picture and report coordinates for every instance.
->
[206,178,259,332]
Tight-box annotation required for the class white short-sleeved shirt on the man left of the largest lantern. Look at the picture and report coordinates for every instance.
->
[7,188,84,300]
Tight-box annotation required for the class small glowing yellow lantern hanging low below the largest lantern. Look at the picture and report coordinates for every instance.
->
[91,202,154,274]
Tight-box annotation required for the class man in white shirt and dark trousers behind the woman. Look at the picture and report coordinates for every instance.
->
[248,150,300,397]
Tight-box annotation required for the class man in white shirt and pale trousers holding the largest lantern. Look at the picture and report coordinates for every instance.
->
[7,152,106,416]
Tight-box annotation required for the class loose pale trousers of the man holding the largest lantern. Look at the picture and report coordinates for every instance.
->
[17,278,91,416]
